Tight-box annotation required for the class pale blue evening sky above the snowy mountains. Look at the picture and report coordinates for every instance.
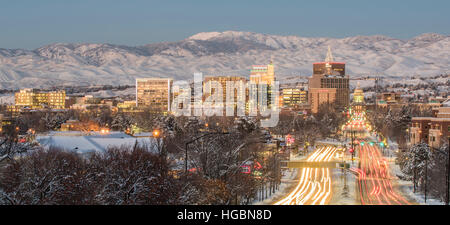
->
[0,0,450,49]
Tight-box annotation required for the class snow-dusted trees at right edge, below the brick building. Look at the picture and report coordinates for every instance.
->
[398,143,448,201]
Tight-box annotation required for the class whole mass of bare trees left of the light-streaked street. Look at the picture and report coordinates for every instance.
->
[0,116,274,205]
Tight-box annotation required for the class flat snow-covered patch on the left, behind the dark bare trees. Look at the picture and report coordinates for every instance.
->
[36,131,153,154]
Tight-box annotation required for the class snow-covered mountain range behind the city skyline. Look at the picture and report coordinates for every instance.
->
[0,31,450,89]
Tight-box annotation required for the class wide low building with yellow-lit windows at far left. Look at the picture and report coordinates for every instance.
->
[14,89,66,109]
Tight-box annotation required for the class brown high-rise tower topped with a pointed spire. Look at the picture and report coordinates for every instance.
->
[308,47,350,113]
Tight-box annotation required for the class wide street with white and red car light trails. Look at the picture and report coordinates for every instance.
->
[274,107,413,205]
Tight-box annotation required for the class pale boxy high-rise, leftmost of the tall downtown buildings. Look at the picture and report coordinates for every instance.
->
[136,78,173,113]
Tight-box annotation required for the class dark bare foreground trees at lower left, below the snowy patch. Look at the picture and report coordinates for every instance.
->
[0,147,183,205]
